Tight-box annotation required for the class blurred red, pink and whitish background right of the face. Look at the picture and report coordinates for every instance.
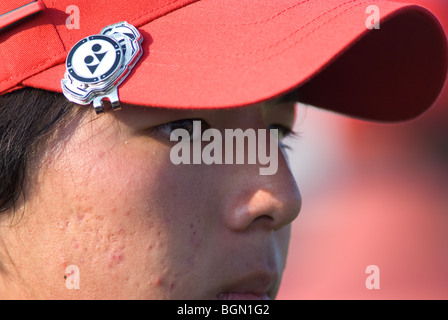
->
[277,0,448,299]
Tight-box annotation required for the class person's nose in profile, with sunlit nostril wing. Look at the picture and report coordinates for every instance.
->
[221,144,302,231]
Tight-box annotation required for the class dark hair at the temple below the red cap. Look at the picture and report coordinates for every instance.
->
[0,88,87,213]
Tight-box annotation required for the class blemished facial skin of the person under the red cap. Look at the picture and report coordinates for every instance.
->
[0,98,301,299]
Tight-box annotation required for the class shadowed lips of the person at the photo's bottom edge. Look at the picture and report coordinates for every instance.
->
[216,271,278,299]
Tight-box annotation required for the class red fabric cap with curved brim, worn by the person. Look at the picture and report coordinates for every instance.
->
[0,0,447,121]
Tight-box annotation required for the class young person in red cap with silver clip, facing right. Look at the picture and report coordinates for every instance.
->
[0,0,447,299]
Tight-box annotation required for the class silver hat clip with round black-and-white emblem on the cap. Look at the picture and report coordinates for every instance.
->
[61,21,143,113]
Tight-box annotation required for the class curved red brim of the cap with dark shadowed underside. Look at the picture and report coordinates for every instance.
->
[23,0,447,121]
